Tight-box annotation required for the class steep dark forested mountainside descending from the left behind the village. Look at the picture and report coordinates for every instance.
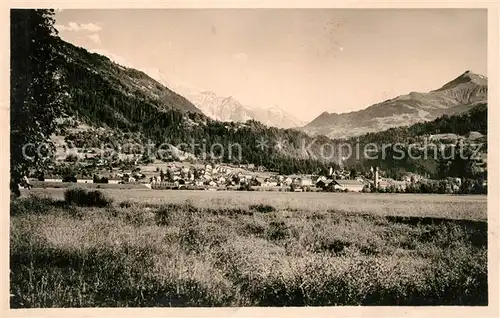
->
[54,40,335,173]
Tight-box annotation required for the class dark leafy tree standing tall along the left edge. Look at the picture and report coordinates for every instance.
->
[10,9,64,196]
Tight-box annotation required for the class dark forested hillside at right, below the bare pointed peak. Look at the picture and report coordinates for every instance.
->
[336,104,488,178]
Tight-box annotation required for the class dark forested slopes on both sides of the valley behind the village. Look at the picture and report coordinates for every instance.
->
[52,41,487,177]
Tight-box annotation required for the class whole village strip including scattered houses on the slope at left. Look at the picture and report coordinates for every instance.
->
[31,130,487,194]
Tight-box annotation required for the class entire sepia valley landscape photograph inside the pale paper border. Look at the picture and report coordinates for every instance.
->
[5,6,497,309]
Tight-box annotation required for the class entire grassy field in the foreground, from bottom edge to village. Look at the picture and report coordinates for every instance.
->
[10,189,488,308]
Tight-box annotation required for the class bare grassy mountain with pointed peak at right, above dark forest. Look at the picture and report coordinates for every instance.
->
[300,71,488,138]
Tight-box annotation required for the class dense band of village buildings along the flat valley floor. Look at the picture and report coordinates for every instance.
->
[32,157,472,193]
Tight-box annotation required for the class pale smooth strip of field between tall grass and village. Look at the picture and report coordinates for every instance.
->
[23,188,487,220]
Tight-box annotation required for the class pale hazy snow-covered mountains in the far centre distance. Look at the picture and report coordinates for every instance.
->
[142,68,305,128]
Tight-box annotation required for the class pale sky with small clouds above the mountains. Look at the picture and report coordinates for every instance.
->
[52,9,487,121]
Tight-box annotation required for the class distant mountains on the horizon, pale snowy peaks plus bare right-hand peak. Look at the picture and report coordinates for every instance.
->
[87,50,488,139]
